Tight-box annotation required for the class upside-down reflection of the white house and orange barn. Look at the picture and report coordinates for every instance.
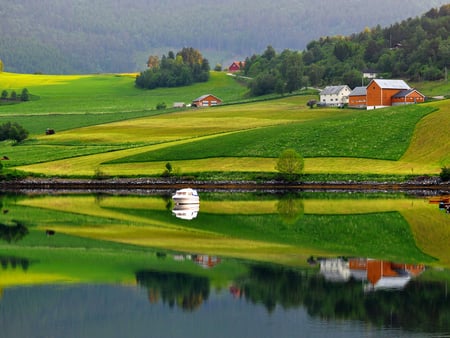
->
[320,258,425,291]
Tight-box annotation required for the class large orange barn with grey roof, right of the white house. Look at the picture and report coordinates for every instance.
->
[366,79,425,109]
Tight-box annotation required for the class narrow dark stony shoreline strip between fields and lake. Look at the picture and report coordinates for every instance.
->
[0,178,450,194]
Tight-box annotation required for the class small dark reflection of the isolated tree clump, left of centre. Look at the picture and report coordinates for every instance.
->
[136,271,209,311]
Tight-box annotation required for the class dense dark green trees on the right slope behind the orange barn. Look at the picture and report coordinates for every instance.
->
[242,4,450,95]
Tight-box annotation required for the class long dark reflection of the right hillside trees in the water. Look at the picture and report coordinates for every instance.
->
[230,266,450,332]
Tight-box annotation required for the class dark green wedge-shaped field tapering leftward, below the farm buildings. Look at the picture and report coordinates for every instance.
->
[111,106,434,163]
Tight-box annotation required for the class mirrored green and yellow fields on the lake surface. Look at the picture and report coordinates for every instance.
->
[0,192,450,286]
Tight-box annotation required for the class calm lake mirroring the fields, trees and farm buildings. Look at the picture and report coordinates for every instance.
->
[0,191,450,337]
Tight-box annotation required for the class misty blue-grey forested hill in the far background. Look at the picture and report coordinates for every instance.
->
[0,0,448,74]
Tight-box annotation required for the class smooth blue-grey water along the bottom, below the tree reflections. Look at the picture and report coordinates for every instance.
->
[0,285,442,338]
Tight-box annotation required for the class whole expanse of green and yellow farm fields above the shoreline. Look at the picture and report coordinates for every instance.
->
[0,72,450,177]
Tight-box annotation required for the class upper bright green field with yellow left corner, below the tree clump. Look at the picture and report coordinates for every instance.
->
[0,72,247,116]
